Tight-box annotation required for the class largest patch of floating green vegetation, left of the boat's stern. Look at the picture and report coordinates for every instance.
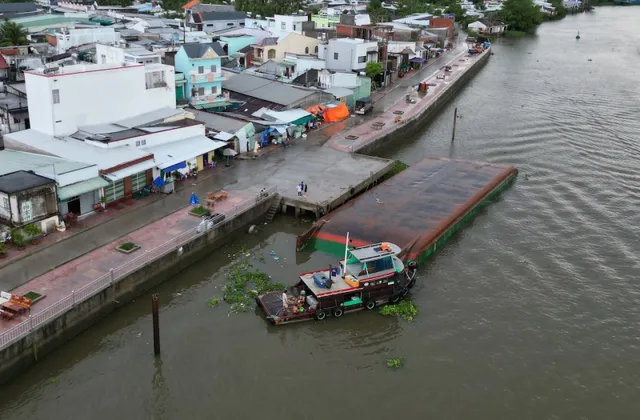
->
[223,260,285,312]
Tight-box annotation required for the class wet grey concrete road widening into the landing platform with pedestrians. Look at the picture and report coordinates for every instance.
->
[0,139,388,291]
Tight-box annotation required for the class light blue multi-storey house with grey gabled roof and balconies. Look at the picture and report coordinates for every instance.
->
[175,42,229,109]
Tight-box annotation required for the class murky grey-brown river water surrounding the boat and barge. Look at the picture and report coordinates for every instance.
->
[0,7,640,420]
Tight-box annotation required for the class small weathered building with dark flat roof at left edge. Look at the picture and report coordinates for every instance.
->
[0,171,59,232]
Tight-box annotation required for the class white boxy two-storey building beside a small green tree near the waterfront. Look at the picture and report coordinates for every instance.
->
[318,38,378,72]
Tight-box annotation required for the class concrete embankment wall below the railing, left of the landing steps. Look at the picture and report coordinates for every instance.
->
[0,195,280,384]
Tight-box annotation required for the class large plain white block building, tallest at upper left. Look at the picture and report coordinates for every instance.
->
[25,63,176,136]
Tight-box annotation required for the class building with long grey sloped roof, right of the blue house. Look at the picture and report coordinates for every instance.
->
[222,73,333,115]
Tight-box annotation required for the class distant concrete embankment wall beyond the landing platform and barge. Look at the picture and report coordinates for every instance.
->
[353,49,491,155]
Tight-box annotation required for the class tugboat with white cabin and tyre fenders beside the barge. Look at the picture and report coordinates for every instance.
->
[256,234,417,325]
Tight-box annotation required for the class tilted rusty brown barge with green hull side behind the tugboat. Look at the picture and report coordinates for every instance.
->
[297,158,518,262]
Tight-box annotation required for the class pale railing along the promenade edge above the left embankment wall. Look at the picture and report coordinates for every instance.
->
[0,187,277,349]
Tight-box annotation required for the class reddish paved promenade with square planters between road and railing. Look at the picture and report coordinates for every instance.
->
[0,193,254,333]
